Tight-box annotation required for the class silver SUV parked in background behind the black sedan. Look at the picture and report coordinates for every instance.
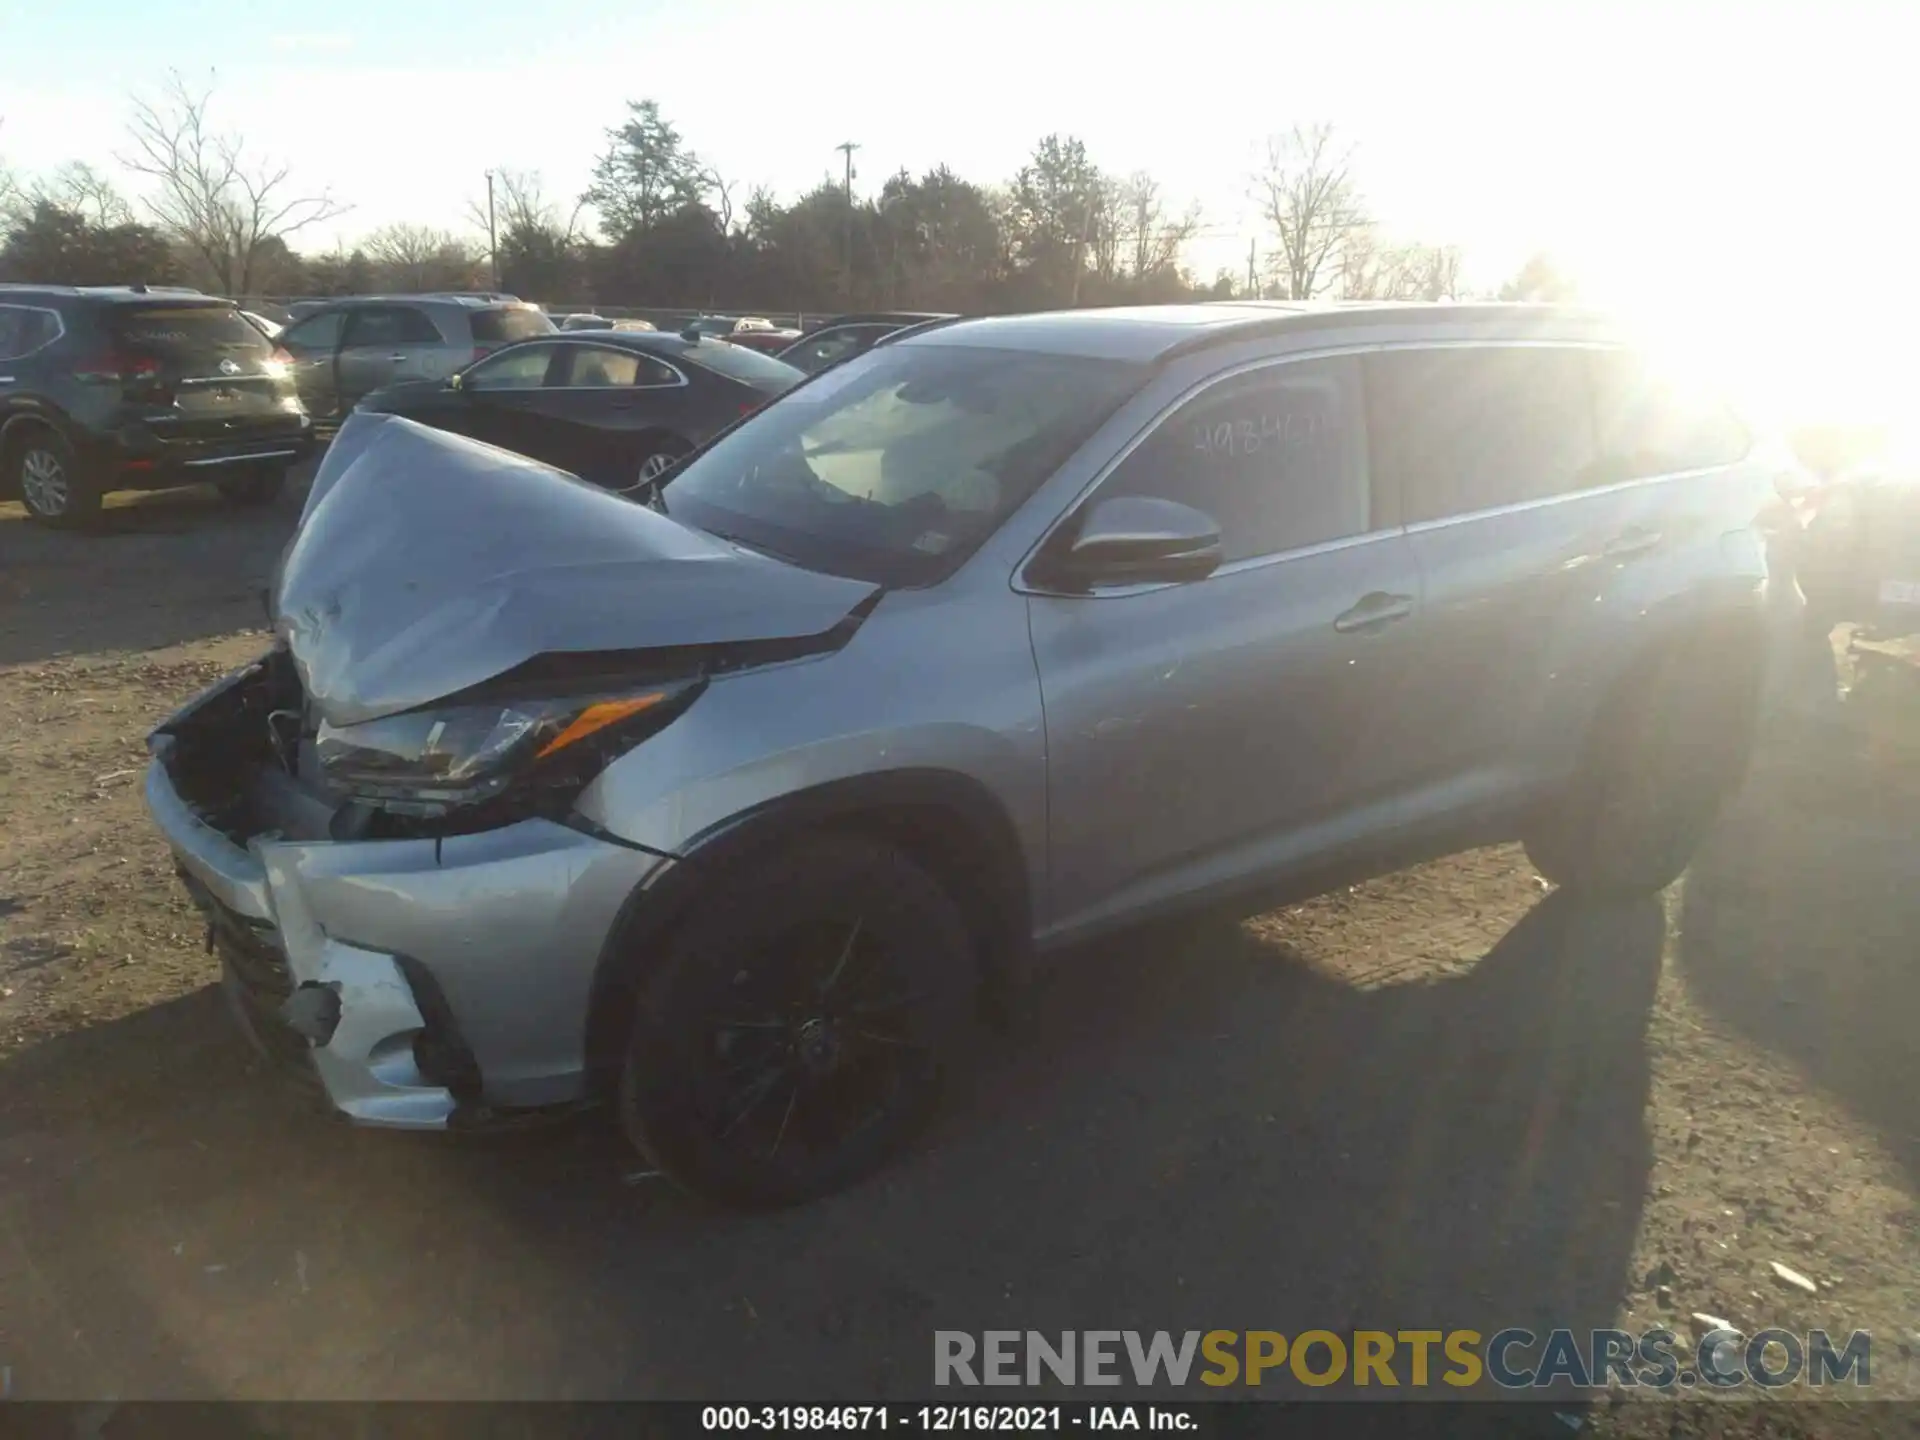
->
[276,296,553,419]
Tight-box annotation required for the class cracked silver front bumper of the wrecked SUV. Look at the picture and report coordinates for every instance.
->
[146,747,672,1129]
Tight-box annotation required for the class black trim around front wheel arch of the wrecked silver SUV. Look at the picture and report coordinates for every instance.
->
[586,768,1033,1091]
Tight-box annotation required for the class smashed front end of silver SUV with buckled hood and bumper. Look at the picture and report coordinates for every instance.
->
[146,415,877,1129]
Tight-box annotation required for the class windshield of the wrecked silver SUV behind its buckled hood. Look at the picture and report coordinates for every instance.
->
[660,346,1144,586]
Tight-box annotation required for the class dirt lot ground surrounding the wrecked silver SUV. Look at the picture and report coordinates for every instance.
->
[0,476,1920,1434]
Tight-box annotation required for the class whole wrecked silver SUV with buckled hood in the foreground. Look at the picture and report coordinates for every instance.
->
[146,305,1780,1204]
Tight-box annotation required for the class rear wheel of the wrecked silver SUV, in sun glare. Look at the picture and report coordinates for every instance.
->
[1526,636,1764,899]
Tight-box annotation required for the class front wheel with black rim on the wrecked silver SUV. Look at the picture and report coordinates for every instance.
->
[620,835,975,1208]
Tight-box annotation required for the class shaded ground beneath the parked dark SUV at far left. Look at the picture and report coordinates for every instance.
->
[0,472,305,664]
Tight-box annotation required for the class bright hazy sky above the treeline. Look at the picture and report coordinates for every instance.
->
[0,0,1920,433]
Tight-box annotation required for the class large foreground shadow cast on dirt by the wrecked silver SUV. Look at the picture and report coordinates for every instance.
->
[0,897,1665,1400]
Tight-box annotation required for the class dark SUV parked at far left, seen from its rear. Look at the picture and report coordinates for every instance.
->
[0,284,313,526]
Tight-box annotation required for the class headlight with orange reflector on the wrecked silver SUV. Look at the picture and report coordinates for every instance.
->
[313,682,699,814]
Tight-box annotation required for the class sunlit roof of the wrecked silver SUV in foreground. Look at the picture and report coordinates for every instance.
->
[885,300,1611,363]
